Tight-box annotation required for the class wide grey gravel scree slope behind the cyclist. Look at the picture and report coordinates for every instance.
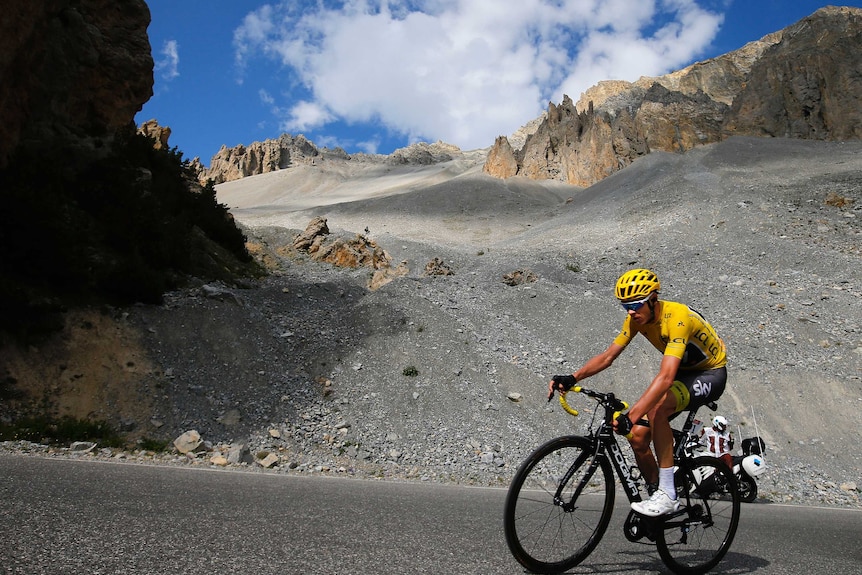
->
[5,138,862,506]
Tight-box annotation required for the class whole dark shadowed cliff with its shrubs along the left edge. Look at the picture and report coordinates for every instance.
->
[0,0,253,342]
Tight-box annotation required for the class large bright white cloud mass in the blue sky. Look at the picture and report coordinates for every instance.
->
[234,0,722,149]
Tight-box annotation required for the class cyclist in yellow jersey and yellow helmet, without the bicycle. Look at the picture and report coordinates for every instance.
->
[548,269,727,517]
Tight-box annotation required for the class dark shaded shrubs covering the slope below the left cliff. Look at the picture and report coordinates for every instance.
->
[0,128,253,340]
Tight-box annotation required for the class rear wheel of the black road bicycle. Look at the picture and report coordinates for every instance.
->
[656,456,741,575]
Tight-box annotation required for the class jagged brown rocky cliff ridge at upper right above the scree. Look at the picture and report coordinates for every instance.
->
[484,7,862,187]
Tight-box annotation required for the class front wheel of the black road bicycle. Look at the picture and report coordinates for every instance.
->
[503,436,614,573]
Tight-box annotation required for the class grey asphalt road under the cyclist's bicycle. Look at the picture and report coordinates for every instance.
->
[0,455,862,575]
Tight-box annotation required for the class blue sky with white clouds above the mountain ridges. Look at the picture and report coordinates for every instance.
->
[135,0,859,165]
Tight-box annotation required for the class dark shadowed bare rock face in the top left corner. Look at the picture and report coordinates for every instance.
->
[0,0,153,168]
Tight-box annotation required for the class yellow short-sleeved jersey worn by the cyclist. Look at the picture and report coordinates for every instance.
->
[614,300,727,370]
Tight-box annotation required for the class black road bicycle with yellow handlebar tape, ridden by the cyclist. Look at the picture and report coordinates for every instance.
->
[503,387,740,574]
